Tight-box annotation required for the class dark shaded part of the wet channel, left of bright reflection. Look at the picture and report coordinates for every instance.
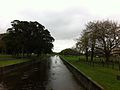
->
[0,60,47,90]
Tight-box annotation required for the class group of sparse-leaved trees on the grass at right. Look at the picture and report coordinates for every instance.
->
[76,20,120,62]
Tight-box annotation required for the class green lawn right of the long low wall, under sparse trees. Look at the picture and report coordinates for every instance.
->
[63,56,120,90]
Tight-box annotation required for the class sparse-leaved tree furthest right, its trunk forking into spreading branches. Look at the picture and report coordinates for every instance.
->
[95,20,120,62]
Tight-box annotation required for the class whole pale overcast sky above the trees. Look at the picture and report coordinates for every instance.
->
[0,0,120,52]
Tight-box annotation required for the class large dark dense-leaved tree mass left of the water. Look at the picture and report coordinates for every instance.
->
[2,20,54,56]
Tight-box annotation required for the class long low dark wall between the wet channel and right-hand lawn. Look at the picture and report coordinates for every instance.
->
[60,57,104,90]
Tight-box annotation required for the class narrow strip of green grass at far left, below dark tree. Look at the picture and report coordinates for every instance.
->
[0,59,29,67]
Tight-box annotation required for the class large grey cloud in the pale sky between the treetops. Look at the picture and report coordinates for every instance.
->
[21,8,91,40]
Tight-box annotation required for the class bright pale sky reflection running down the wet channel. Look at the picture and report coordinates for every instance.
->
[46,56,82,90]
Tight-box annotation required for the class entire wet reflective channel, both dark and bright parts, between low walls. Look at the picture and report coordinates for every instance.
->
[0,56,83,90]
